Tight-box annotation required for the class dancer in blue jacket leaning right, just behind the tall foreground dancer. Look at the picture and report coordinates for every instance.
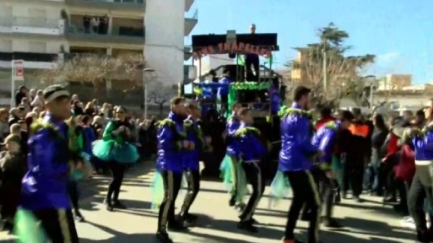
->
[313,111,354,228]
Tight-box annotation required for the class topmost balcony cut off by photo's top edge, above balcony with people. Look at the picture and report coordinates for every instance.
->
[65,0,146,12]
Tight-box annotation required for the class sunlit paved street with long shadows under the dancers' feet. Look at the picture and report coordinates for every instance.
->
[0,165,413,243]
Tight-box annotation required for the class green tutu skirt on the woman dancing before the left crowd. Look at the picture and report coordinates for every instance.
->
[92,140,140,163]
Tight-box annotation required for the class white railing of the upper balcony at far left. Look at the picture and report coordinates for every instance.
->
[0,17,60,28]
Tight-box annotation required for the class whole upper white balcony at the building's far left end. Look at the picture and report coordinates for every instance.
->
[0,17,65,36]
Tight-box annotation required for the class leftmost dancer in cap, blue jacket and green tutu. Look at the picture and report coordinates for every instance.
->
[16,85,79,243]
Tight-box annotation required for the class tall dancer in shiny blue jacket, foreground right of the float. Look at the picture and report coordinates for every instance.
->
[278,86,321,243]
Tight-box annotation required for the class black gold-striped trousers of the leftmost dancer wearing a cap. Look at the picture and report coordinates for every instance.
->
[33,209,79,243]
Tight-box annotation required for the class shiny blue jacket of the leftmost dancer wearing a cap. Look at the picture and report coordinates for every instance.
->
[22,114,71,210]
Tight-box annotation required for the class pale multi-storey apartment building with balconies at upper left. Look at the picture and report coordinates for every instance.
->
[0,0,198,94]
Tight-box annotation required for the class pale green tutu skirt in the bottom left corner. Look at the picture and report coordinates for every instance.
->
[14,209,48,243]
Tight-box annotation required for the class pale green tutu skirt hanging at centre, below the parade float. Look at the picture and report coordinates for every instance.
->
[220,155,248,203]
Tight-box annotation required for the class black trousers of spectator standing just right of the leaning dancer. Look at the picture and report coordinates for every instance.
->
[342,164,364,197]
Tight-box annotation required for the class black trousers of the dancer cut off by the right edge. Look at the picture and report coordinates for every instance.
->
[408,174,433,233]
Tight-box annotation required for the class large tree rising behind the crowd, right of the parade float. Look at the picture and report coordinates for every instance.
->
[286,23,375,104]
